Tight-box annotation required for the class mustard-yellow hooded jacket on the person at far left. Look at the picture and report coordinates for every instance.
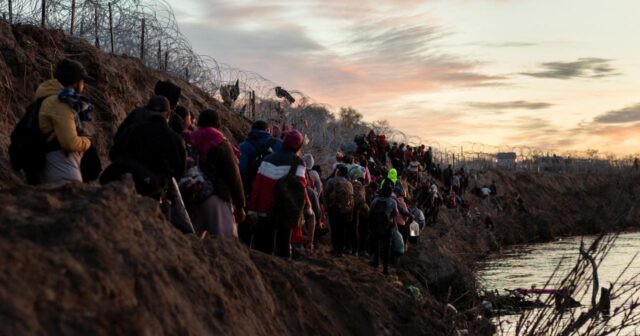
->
[35,79,91,152]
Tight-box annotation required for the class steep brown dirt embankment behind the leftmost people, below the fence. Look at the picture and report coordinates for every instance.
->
[0,20,250,186]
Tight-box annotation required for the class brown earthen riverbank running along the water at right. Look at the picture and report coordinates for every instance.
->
[401,170,640,320]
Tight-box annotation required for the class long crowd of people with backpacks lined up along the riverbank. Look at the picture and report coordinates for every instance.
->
[12,59,495,273]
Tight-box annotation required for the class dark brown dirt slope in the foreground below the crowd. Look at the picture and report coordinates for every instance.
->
[0,183,464,335]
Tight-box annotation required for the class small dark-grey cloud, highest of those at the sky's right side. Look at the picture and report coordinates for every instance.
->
[520,57,618,79]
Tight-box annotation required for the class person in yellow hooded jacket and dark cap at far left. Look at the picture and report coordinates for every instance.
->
[36,59,93,182]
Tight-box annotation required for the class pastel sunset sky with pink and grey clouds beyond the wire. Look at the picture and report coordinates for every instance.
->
[172,0,640,154]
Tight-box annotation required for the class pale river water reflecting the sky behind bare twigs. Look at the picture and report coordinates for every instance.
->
[479,232,640,335]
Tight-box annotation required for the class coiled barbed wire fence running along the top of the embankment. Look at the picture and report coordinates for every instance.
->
[0,0,631,171]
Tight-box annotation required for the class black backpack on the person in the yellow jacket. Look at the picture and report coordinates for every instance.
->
[9,97,57,185]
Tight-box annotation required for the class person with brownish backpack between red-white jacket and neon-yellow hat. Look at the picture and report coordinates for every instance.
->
[324,164,355,256]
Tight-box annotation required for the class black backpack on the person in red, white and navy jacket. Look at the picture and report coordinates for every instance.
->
[269,155,307,229]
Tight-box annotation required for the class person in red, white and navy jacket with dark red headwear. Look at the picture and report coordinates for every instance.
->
[248,130,311,258]
